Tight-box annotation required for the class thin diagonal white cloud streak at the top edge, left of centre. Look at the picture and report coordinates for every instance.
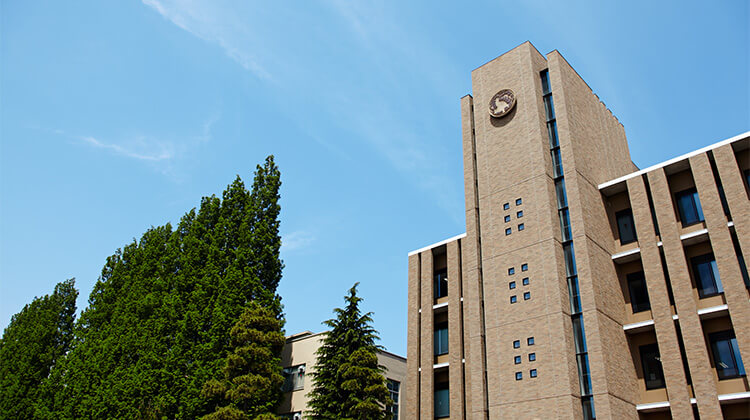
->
[142,0,271,79]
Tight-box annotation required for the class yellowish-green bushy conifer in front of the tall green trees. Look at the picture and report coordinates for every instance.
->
[203,302,285,420]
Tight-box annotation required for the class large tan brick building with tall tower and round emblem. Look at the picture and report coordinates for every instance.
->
[402,42,750,420]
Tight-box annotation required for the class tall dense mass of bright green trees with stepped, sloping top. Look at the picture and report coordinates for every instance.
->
[37,156,283,419]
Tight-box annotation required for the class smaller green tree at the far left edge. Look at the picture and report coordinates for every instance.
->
[0,279,78,419]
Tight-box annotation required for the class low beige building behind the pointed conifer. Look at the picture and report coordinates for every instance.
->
[278,331,407,420]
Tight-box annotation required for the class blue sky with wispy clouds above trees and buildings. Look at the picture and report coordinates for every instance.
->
[0,0,750,355]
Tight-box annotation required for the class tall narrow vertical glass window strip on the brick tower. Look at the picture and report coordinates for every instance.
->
[540,70,596,420]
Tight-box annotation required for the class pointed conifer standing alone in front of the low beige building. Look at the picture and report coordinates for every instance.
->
[310,283,393,420]
